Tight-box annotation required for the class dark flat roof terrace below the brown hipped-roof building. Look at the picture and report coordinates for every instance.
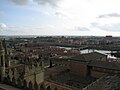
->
[51,72,96,89]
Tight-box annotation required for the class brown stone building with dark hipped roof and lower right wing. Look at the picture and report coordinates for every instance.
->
[70,52,120,78]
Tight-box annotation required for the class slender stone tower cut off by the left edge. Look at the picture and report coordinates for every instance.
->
[0,42,5,81]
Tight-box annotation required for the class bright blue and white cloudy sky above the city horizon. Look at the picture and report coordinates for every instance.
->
[0,0,120,36]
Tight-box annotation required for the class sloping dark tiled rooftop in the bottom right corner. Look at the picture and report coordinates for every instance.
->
[83,75,120,90]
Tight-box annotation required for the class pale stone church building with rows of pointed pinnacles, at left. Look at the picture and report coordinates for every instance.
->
[0,41,44,90]
